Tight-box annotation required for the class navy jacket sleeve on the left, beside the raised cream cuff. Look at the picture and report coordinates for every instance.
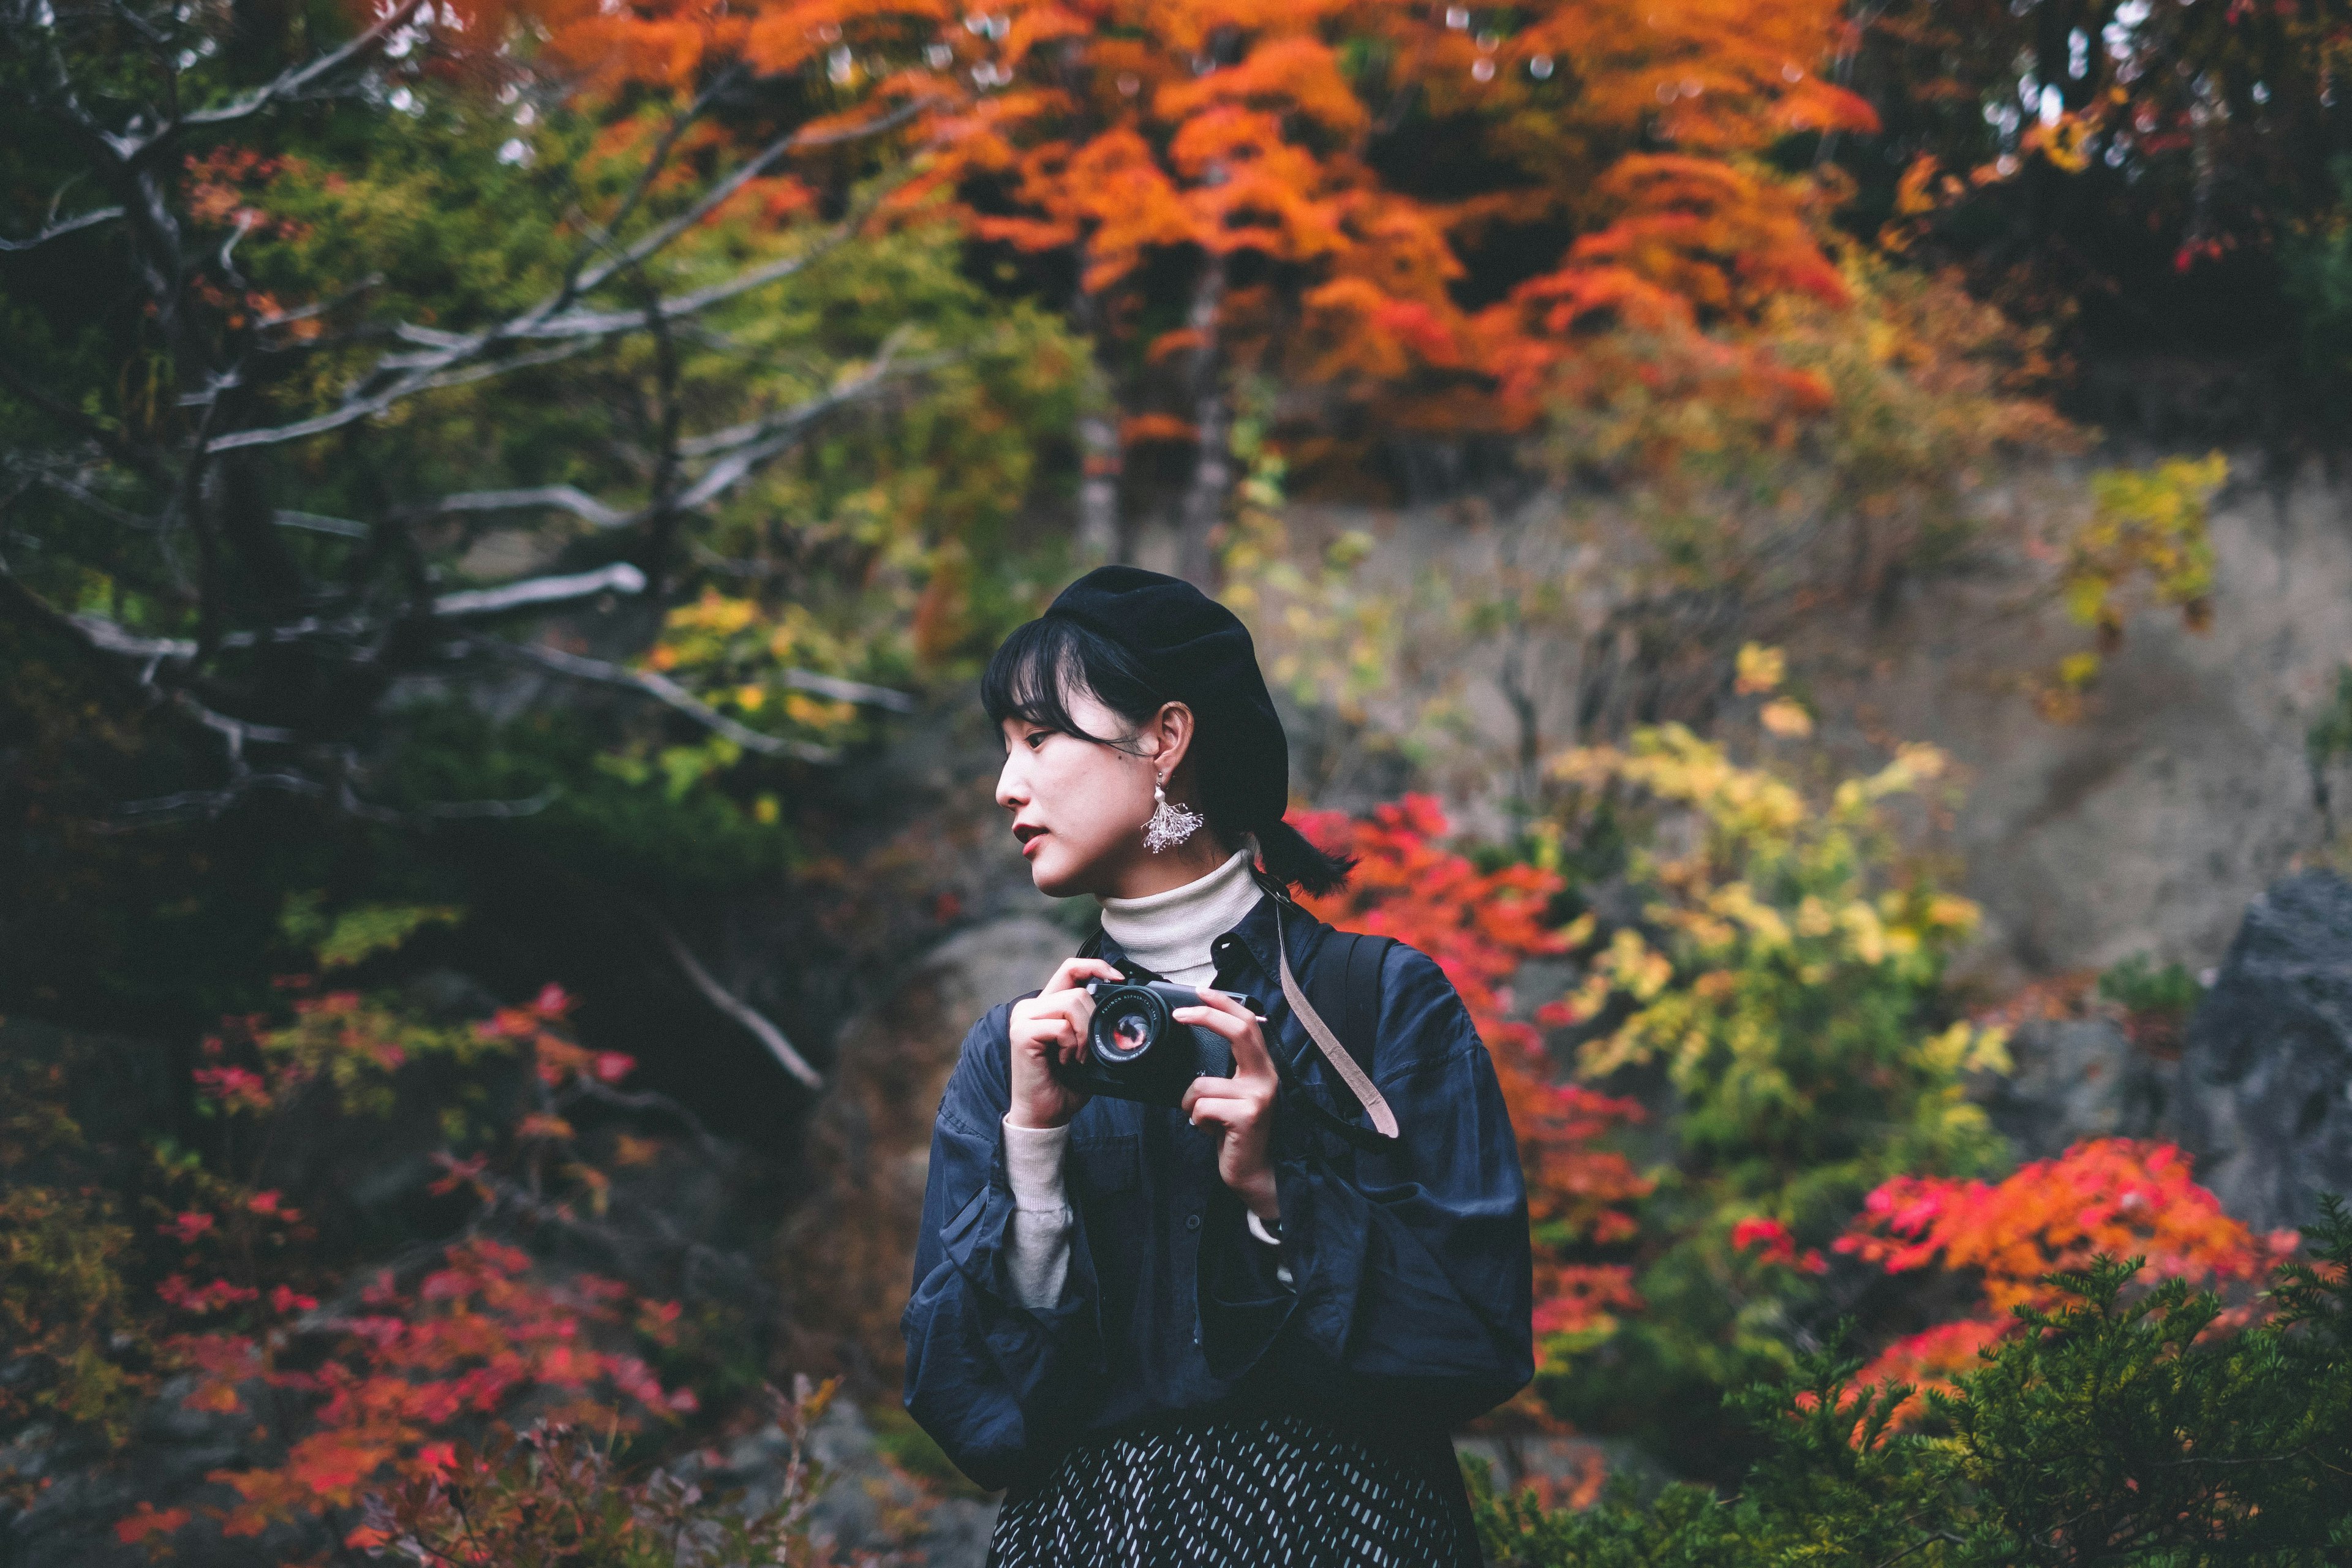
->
[899,1004,1103,1490]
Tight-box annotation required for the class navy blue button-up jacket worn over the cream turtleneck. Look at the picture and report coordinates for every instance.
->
[901,898,1534,1488]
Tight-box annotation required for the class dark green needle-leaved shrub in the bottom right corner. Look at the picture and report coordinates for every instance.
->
[1470,1199,2352,1568]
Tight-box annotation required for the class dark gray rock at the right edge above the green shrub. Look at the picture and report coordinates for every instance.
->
[2176,870,2352,1229]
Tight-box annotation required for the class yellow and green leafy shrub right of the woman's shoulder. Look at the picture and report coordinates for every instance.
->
[1540,705,2007,1476]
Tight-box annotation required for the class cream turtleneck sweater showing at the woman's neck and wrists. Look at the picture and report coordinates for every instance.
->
[1005,842,1291,1307]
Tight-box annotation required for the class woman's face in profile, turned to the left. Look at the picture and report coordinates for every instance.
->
[997,691,1209,898]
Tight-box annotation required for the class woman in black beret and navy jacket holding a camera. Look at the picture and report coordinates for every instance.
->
[901,567,1534,1568]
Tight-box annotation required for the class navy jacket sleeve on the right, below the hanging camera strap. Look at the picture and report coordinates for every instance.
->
[1199,945,1536,1427]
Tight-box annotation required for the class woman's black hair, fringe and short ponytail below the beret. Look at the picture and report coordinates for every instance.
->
[981,616,1355,895]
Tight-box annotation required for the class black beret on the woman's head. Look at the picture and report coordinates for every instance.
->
[1044,567,1291,832]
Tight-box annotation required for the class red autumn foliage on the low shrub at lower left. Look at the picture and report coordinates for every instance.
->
[118,985,696,1547]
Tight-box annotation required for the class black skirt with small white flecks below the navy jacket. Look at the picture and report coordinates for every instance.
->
[988,1415,1479,1568]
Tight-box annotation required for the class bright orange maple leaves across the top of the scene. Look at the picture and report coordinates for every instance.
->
[442,0,1874,447]
